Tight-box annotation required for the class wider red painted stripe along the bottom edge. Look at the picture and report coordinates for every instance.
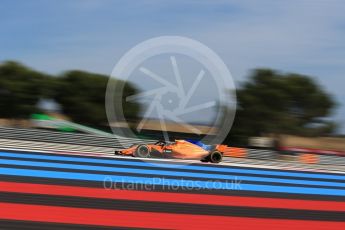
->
[0,203,345,230]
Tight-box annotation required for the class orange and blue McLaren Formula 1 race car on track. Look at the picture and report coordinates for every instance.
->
[115,140,227,163]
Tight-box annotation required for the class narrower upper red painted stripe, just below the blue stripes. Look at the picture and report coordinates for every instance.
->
[0,182,345,211]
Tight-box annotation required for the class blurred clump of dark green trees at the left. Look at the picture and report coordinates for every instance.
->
[0,62,140,127]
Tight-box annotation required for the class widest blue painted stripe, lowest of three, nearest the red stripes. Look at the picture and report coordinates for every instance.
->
[0,168,345,196]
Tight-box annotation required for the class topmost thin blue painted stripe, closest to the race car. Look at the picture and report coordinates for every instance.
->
[0,152,345,180]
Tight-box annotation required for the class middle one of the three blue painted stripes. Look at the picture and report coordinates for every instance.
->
[0,159,345,188]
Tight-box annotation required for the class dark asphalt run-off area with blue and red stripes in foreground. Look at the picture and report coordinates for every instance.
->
[0,150,345,229]
